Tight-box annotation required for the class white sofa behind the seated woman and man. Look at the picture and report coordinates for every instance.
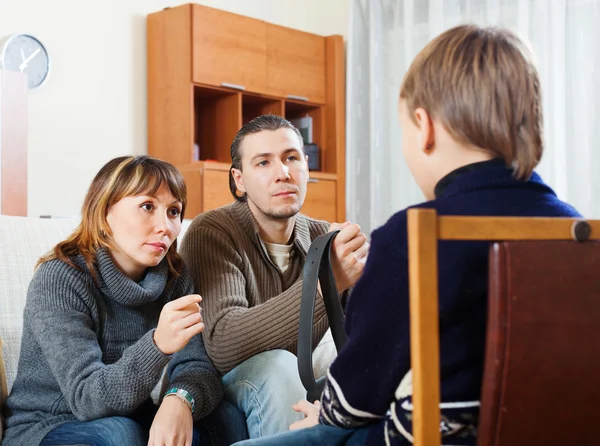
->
[0,215,335,439]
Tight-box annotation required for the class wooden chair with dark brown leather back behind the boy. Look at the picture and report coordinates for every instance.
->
[408,209,600,446]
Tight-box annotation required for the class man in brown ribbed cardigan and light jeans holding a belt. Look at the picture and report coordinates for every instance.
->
[181,115,369,438]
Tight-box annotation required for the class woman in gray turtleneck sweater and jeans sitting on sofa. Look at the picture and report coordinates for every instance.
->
[3,156,246,446]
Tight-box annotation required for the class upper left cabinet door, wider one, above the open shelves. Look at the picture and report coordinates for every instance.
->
[192,5,267,93]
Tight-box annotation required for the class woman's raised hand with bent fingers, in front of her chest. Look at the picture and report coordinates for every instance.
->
[154,294,204,355]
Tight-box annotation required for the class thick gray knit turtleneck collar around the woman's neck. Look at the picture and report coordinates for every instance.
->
[96,248,169,307]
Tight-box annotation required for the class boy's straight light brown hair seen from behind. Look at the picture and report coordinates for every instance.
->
[400,25,544,179]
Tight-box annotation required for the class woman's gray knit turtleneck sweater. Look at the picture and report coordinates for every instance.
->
[2,250,223,446]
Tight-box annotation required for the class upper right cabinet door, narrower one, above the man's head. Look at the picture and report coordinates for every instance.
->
[266,23,325,104]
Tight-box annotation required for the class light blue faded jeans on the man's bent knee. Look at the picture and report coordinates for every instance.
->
[223,350,306,438]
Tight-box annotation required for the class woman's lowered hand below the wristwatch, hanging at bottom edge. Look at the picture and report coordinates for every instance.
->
[148,396,194,446]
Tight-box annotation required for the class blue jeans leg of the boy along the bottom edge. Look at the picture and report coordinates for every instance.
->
[235,424,369,446]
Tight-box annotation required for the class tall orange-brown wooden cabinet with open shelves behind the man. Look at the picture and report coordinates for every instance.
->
[147,4,346,221]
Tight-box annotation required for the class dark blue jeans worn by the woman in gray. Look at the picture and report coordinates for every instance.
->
[40,401,248,446]
